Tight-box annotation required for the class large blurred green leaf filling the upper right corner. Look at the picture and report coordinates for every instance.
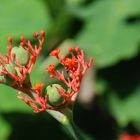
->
[71,0,140,68]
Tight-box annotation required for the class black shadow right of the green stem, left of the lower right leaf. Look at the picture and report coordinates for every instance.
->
[74,96,118,140]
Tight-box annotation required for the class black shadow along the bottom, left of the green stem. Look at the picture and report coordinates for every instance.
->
[4,113,71,140]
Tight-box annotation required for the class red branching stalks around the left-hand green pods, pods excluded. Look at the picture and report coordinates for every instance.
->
[0,31,45,83]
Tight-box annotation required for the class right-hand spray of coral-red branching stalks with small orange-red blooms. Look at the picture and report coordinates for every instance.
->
[47,47,92,109]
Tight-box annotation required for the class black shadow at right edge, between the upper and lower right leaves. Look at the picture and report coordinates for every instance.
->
[98,55,140,98]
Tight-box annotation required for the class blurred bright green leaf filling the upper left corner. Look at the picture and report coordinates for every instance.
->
[0,0,51,52]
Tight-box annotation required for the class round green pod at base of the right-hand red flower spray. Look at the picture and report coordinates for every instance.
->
[46,84,64,106]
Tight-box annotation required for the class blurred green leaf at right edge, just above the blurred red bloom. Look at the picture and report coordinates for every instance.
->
[109,88,140,129]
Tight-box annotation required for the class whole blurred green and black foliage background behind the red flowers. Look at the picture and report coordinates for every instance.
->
[0,0,140,140]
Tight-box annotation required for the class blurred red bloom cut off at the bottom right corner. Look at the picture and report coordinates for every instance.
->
[119,134,140,140]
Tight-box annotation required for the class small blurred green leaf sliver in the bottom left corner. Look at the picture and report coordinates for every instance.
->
[0,115,10,140]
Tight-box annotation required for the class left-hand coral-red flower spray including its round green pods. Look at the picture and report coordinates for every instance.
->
[0,31,45,84]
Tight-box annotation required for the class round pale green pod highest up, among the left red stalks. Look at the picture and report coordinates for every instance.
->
[11,46,30,66]
